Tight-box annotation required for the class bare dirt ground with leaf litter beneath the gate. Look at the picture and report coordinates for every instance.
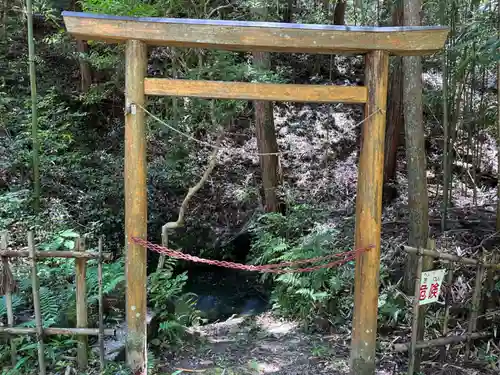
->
[162,313,495,375]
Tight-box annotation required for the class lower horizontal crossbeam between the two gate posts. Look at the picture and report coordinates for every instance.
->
[144,78,368,103]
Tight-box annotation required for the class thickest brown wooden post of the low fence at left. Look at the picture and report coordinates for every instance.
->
[75,238,89,371]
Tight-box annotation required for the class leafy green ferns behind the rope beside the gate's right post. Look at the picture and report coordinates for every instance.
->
[250,205,408,327]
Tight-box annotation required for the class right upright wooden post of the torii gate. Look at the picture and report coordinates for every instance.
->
[351,51,389,375]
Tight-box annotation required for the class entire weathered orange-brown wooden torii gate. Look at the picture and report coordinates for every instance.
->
[63,12,448,375]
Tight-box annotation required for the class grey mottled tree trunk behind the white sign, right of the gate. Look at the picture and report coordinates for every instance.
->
[403,0,429,295]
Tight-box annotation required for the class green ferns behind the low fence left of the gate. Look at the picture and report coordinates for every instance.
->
[0,229,124,375]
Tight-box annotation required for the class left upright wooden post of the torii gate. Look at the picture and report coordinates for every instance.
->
[125,40,147,373]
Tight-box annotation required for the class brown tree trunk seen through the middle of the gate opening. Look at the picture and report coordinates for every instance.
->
[253,7,280,212]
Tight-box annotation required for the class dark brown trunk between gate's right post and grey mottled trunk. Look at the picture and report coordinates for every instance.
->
[384,0,404,189]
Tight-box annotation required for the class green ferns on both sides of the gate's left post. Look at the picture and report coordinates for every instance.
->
[0,229,200,375]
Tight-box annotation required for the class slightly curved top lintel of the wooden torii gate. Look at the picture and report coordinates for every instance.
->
[63,11,448,56]
